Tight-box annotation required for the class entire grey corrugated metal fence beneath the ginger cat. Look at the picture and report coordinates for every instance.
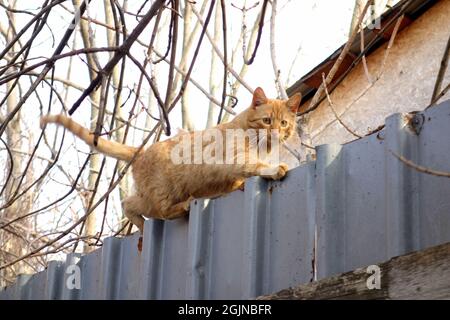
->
[0,101,450,299]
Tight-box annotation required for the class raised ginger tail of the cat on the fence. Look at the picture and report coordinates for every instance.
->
[40,114,142,161]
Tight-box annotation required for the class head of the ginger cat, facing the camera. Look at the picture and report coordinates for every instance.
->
[247,87,302,143]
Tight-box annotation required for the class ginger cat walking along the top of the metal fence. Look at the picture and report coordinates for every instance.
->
[41,88,301,233]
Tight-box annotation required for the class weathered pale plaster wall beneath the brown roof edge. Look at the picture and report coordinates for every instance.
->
[306,0,450,145]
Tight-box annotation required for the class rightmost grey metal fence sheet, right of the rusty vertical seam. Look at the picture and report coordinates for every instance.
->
[316,102,450,278]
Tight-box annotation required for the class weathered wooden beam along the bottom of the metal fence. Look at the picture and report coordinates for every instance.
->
[258,243,450,300]
